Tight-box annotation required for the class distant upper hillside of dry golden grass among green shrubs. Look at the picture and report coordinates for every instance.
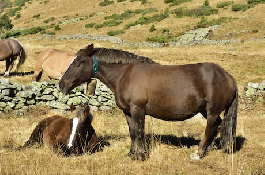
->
[4,0,265,42]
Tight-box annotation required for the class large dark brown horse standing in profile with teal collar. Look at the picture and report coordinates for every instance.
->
[59,44,238,160]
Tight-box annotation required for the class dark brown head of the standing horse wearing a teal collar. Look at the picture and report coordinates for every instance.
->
[59,44,94,94]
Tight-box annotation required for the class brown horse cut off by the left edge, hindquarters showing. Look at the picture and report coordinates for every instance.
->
[0,39,26,76]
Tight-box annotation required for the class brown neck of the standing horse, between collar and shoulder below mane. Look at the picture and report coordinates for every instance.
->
[97,64,128,92]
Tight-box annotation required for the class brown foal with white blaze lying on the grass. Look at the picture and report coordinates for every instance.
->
[19,105,97,155]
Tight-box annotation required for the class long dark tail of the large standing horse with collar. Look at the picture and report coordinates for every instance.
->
[220,90,238,153]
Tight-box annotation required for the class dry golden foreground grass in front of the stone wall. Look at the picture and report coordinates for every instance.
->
[0,104,265,175]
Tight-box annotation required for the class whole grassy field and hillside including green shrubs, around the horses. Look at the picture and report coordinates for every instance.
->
[0,0,265,175]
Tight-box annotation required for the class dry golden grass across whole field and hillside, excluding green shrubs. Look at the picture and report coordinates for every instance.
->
[0,0,265,174]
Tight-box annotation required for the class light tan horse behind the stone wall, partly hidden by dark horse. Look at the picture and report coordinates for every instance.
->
[32,49,96,95]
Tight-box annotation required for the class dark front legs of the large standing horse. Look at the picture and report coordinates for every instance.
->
[125,106,146,160]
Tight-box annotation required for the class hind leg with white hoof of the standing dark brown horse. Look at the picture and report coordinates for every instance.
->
[190,114,222,159]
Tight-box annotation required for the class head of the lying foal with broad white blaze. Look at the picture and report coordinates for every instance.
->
[67,105,94,148]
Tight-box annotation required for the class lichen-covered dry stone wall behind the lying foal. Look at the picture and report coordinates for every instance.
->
[0,79,116,114]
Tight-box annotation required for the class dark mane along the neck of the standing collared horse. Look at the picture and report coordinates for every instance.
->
[93,48,155,64]
